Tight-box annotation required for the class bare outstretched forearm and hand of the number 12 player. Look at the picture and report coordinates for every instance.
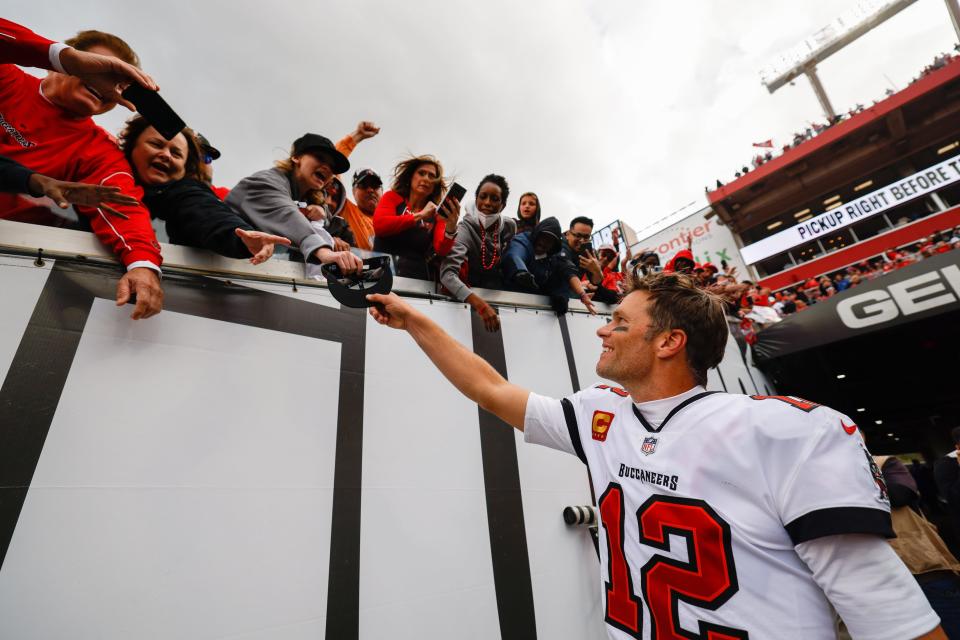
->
[367,293,530,431]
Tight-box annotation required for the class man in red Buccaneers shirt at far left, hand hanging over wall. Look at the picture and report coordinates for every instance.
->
[0,19,163,319]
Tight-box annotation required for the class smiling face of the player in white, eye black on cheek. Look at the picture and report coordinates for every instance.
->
[597,291,655,389]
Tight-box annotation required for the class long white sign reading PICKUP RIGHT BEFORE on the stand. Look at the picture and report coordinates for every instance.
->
[740,155,960,264]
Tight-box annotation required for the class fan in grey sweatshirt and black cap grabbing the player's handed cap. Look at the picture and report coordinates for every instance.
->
[226,133,363,273]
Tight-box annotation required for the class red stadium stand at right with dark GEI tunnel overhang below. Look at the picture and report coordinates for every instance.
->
[705,11,960,456]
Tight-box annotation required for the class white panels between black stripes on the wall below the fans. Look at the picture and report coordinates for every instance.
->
[0,256,763,640]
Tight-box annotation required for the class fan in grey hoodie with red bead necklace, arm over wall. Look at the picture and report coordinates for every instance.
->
[440,174,517,331]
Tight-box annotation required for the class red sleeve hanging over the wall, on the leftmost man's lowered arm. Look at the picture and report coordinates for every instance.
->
[71,134,163,267]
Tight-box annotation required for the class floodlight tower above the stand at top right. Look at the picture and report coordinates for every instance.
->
[761,0,960,120]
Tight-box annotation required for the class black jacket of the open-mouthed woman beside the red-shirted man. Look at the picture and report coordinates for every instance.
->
[143,178,254,258]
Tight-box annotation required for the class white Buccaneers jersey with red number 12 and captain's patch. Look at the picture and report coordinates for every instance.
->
[524,385,893,640]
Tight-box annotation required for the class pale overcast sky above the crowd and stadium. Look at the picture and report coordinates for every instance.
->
[4,0,956,238]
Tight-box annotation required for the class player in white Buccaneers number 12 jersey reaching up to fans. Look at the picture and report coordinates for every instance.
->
[370,273,947,640]
